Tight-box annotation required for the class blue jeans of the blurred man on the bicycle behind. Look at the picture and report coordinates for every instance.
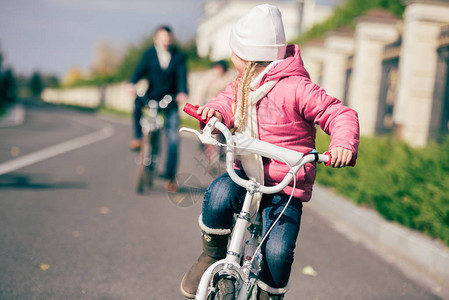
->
[133,97,179,180]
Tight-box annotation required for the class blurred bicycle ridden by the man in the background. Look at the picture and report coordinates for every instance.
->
[136,95,173,194]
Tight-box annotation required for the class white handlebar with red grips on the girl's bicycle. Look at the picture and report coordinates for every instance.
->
[180,103,355,194]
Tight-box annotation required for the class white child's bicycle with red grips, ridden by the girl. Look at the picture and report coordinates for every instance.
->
[180,104,355,300]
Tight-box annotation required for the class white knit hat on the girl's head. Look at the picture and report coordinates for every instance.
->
[229,4,287,61]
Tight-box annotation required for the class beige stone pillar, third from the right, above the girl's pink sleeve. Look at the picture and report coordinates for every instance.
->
[322,28,354,101]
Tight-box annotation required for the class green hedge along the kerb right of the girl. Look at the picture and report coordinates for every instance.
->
[317,133,449,246]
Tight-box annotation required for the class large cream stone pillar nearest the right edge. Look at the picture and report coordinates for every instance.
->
[393,0,449,146]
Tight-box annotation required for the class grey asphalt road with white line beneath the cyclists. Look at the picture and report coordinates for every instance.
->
[0,104,438,300]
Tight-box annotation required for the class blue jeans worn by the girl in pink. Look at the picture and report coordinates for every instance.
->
[202,171,302,288]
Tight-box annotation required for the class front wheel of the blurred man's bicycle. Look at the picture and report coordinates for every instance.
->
[136,134,153,194]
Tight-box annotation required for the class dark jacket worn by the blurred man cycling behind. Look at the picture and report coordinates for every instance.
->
[130,47,187,103]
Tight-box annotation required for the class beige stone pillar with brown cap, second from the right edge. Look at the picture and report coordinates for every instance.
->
[348,10,399,135]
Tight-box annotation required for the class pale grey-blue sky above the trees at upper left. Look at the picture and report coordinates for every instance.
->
[0,0,337,77]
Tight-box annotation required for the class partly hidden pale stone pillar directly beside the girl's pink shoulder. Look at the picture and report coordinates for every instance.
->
[300,40,324,85]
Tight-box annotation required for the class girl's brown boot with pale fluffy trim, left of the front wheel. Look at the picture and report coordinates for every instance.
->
[181,231,229,299]
